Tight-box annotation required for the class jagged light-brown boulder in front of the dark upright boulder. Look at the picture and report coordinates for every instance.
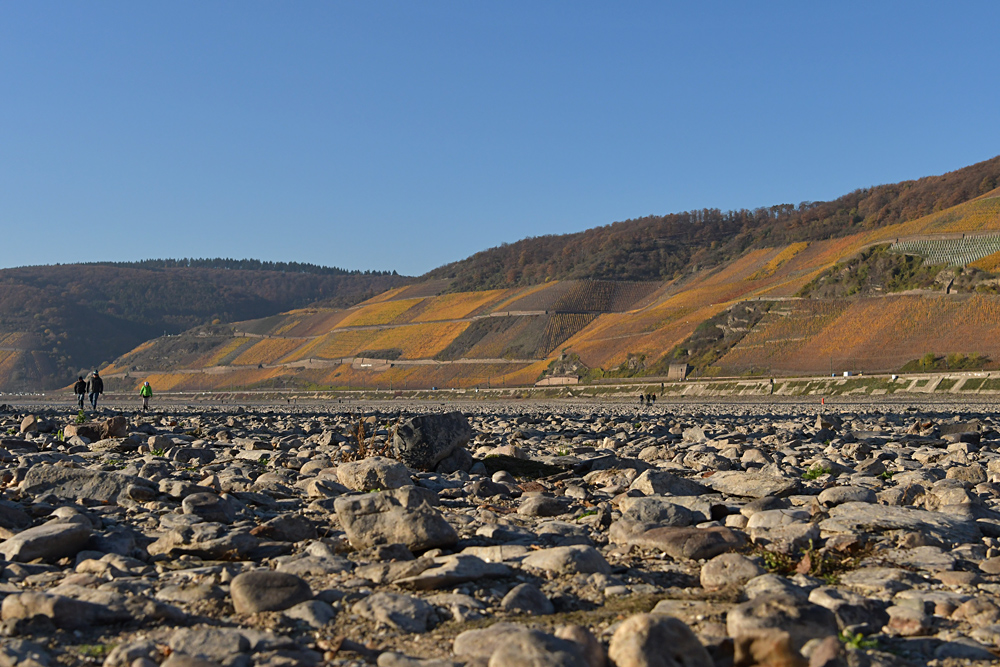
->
[334,486,458,551]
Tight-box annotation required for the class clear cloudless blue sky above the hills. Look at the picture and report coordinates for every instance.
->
[0,0,1000,275]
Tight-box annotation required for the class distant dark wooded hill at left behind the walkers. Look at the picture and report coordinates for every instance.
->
[0,260,409,391]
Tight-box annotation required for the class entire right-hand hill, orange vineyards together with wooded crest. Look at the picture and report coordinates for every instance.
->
[97,158,1000,391]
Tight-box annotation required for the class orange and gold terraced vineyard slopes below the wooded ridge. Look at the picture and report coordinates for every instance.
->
[99,192,1000,391]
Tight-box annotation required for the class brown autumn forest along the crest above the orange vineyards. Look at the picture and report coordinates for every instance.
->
[424,157,1000,291]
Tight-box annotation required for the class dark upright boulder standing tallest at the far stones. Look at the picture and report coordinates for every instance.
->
[392,411,472,470]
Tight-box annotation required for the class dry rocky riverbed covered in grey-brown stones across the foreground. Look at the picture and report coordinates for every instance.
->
[0,402,1000,667]
